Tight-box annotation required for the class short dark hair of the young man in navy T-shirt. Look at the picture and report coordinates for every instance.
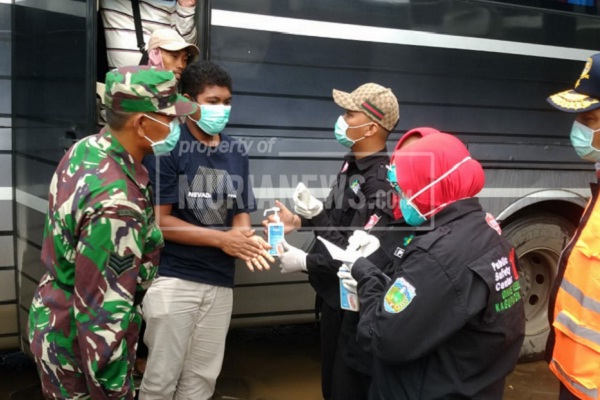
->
[179,61,232,98]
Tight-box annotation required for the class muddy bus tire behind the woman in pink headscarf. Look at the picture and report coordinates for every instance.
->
[502,213,575,362]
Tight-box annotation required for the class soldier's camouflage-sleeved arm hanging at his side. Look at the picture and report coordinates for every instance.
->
[72,199,149,399]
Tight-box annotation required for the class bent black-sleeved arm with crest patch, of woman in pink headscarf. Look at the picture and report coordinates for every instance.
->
[351,251,469,364]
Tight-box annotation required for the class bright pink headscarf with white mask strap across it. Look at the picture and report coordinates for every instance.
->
[393,133,485,219]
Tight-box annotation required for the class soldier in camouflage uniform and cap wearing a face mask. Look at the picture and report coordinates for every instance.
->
[29,66,197,399]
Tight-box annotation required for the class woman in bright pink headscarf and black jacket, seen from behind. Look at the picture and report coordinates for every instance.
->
[342,133,525,400]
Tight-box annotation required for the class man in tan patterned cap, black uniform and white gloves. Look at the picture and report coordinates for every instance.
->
[265,83,399,400]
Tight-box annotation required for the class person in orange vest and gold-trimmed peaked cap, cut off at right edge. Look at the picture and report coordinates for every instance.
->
[546,54,600,400]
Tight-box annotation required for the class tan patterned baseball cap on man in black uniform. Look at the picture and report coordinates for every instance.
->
[333,83,400,131]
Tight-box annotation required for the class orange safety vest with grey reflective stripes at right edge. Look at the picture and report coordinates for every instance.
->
[550,185,600,400]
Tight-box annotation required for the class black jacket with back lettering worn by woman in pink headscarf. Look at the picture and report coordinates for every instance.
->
[352,198,525,400]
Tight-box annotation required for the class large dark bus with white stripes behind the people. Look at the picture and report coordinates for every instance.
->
[5,0,600,360]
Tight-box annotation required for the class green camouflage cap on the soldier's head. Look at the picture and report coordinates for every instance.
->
[104,65,197,116]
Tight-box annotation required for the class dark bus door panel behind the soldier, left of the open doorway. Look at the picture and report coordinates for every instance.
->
[12,0,96,349]
